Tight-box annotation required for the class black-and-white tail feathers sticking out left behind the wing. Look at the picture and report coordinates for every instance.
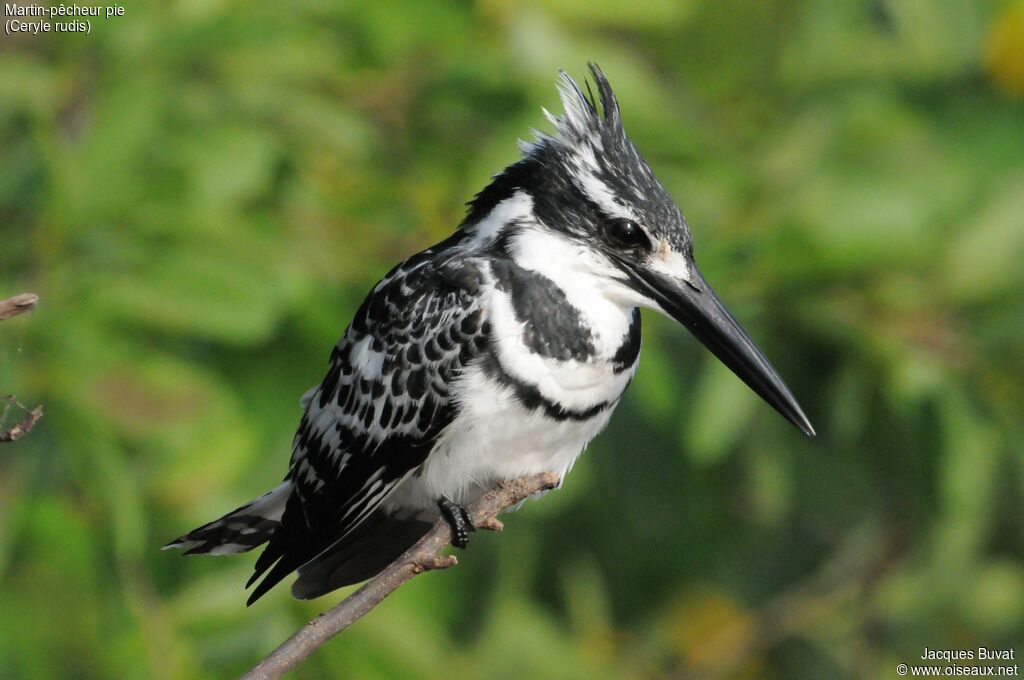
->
[164,480,292,555]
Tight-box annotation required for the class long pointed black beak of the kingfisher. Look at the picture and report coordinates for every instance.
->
[621,261,814,436]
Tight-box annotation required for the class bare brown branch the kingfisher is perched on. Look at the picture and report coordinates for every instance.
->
[242,472,558,680]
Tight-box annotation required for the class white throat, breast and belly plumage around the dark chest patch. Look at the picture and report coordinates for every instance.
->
[383,229,636,518]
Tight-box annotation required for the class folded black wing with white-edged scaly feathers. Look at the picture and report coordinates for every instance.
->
[249,250,487,603]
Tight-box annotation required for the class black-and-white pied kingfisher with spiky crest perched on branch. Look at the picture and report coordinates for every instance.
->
[165,63,814,604]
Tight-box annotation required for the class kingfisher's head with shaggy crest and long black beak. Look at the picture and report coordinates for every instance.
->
[462,63,814,435]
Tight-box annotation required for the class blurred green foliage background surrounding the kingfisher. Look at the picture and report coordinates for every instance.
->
[0,0,1024,680]
